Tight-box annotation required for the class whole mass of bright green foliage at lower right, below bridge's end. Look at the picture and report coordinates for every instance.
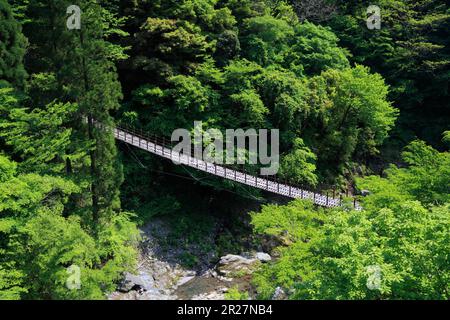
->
[252,142,450,300]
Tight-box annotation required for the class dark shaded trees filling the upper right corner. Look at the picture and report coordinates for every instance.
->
[327,0,450,147]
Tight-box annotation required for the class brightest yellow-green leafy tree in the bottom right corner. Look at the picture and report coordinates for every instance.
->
[295,201,450,299]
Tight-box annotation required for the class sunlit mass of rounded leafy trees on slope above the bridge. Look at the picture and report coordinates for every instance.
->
[123,1,397,185]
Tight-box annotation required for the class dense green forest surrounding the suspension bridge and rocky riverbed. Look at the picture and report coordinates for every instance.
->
[0,0,450,300]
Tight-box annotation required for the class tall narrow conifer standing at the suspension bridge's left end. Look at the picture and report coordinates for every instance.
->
[66,1,123,229]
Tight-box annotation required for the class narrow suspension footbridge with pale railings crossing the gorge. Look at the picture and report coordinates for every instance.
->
[94,120,362,210]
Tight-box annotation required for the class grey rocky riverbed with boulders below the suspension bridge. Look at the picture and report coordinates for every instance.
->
[109,215,272,300]
